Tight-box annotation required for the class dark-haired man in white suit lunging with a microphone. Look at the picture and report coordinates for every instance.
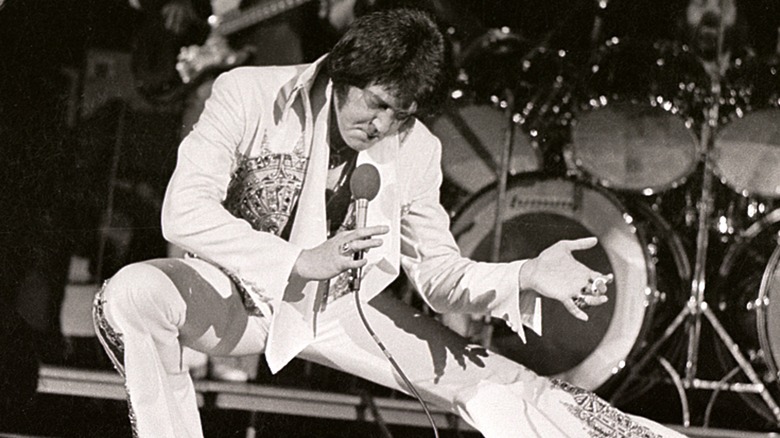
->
[95,9,679,437]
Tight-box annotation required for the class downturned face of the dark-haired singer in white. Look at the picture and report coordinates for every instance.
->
[333,84,417,151]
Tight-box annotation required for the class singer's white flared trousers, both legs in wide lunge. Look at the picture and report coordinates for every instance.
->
[95,259,683,438]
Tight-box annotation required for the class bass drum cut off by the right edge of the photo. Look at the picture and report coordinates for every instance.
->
[715,210,780,422]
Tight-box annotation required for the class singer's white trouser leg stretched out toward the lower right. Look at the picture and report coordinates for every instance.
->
[302,293,683,438]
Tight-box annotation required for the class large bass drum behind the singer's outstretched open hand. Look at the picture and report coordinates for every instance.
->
[444,174,690,390]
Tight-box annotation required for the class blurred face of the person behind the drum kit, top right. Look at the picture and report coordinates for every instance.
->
[686,0,737,60]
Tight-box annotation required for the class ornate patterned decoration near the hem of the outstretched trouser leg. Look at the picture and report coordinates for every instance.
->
[551,379,663,438]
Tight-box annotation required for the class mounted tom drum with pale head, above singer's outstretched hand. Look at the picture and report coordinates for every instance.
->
[566,40,709,194]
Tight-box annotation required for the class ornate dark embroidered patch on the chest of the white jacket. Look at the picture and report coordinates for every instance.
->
[224,147,308,236]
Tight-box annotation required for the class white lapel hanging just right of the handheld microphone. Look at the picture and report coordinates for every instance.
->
[357,135,401,300]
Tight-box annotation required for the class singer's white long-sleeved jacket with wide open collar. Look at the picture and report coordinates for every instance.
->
[162,55,541,372]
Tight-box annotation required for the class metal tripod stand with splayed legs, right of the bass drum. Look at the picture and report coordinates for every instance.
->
[612,70,780,427]
